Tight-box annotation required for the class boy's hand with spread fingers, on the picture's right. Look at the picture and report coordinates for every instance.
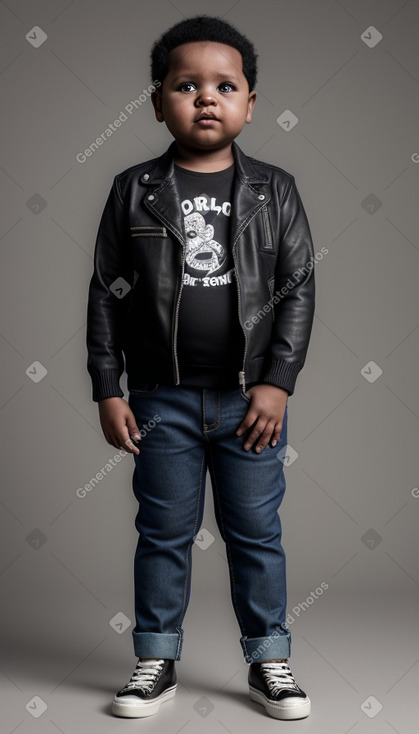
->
[236,384,288,454]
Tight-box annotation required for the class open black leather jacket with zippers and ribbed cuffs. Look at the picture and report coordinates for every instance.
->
[87,143,315,401]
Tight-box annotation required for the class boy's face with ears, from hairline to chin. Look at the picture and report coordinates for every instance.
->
[152,41,256,156]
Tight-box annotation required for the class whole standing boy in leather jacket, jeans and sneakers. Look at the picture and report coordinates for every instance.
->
[87,16,314,719]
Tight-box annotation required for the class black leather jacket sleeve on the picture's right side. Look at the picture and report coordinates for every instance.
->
[262,178,315,395]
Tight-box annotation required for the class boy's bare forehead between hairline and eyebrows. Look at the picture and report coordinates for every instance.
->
[168,41,244,77]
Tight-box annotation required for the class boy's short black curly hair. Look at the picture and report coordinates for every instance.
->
[151,15,257,92]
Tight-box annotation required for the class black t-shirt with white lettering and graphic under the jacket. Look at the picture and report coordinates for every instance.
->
[175,164,244,389]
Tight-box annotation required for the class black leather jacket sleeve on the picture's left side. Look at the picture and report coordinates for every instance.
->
[86,178,131,402]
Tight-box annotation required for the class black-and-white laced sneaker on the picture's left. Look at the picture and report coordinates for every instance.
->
[112,658,177,719]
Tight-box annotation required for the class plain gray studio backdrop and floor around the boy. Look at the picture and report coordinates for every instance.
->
[0,0,419,734]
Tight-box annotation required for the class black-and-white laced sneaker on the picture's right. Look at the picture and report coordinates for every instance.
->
[249,662,310,719]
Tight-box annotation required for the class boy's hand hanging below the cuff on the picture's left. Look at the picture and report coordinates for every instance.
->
[99,398,141,454]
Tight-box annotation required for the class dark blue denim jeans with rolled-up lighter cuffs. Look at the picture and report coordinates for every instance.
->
[128,384,291,663]
